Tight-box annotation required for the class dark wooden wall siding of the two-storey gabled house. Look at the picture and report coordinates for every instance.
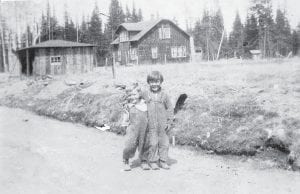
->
[113,21,191,65]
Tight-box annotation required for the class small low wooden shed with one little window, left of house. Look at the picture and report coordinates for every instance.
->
[17,40,96,76]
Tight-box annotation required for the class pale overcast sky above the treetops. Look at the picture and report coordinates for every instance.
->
[2,0,300,31]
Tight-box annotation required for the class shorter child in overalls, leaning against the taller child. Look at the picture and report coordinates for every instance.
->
[123,89,150,171]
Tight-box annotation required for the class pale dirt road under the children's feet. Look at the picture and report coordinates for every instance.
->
[0,107,300,194]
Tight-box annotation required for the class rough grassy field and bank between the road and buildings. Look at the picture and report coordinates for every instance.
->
[0,58,300,164]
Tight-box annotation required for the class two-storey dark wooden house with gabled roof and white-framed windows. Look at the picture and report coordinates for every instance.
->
[111,19,191,65]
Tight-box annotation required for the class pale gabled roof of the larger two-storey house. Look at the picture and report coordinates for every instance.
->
[111,19,190,44]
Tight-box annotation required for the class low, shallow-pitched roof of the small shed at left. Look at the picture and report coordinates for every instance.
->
[19,40,96,50]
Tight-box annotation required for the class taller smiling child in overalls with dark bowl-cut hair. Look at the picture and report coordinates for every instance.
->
[142,71,174,170]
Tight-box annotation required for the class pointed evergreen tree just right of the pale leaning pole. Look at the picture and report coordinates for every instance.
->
[228,12,244,57]
